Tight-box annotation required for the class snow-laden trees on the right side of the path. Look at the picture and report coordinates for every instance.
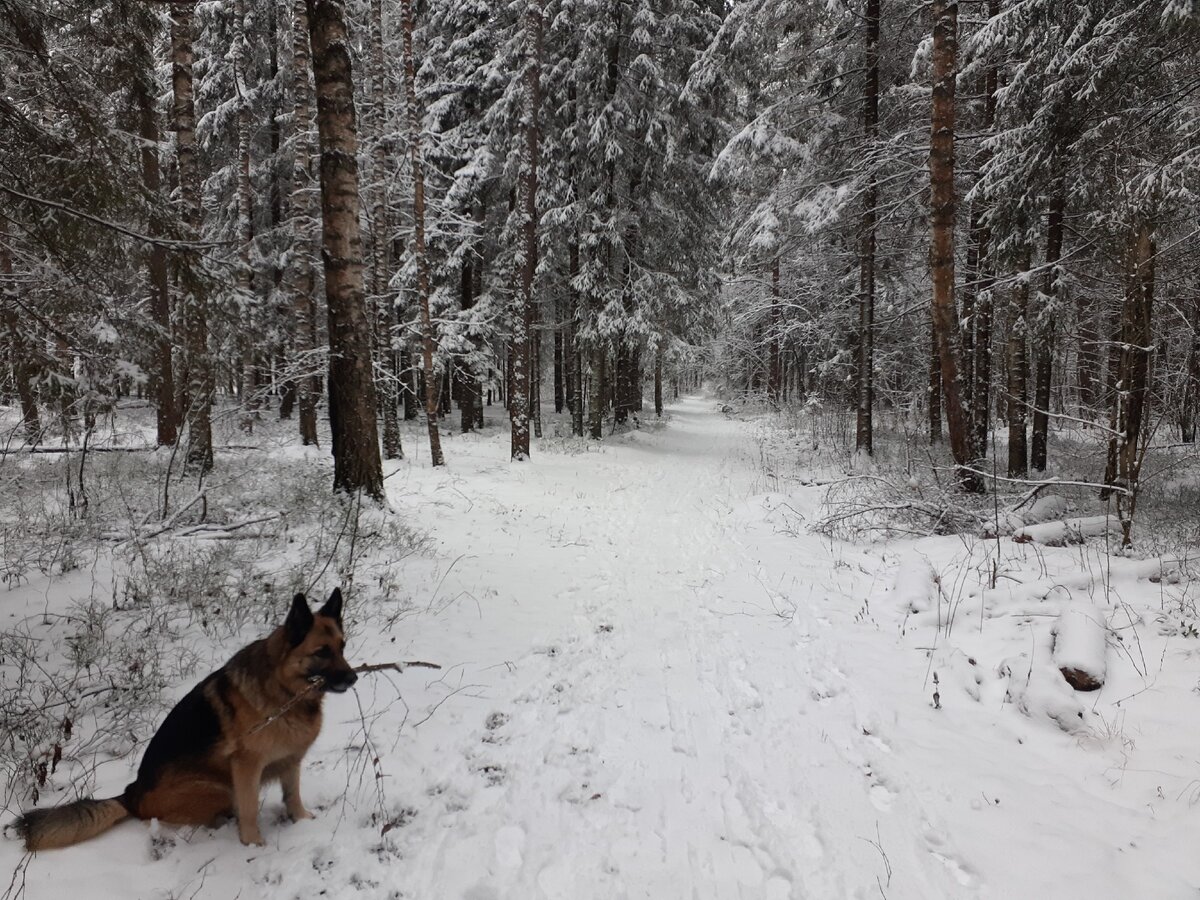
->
[694,0,1200,513]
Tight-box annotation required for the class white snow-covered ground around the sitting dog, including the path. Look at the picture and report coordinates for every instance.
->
[0,396,1200,900]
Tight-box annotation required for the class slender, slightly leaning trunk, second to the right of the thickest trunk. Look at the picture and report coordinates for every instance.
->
[400,0,445,466]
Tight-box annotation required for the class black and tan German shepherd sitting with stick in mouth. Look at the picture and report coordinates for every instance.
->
[16,589,358,850]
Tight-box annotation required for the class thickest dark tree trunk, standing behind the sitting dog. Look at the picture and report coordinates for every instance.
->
[307,0,384,499]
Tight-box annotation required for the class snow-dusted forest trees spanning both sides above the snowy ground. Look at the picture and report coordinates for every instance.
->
[0,0,1200,520]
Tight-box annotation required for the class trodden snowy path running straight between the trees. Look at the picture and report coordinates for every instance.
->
[386,397,976,900]
